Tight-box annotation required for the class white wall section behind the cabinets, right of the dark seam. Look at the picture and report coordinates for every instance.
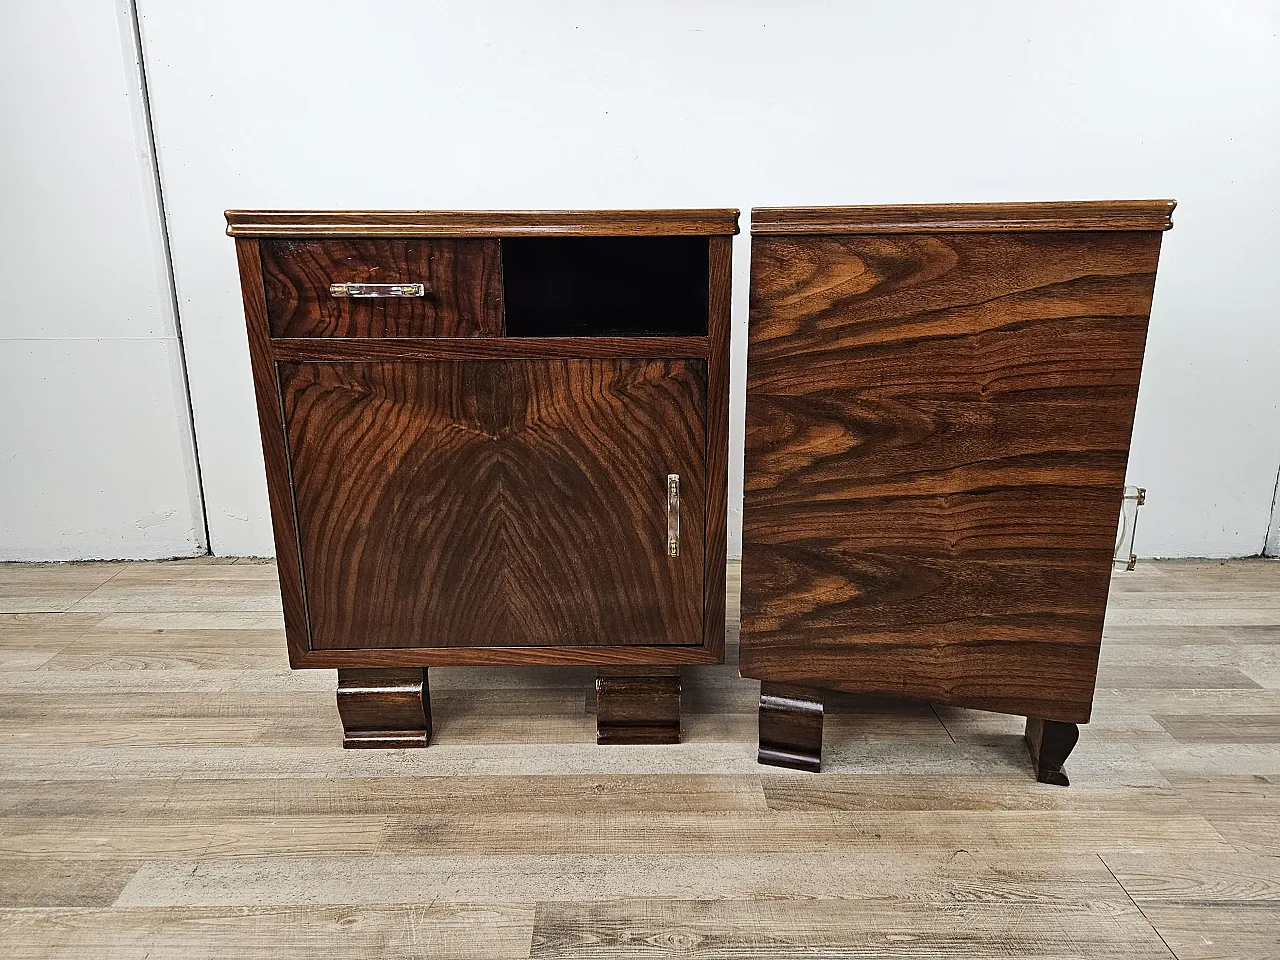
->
[132,0,1280,556]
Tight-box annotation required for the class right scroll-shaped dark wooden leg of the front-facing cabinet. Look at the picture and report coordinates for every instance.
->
[595,667,680,744]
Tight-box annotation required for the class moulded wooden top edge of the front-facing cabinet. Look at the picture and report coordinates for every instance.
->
[227,210,739,237]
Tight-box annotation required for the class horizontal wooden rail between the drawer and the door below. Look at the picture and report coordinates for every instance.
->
[271,337,712,361]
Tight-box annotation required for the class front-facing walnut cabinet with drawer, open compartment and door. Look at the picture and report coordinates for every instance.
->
[227,210,737,746]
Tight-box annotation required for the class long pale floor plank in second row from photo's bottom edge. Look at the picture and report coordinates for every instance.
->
[116,850,1125,910]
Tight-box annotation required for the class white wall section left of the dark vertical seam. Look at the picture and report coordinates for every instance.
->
[0,0,203,559]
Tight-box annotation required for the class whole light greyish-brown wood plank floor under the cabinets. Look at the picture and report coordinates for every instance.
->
[0,559,1280,960]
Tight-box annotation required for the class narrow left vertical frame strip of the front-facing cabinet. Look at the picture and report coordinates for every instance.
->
[236,238,310,663]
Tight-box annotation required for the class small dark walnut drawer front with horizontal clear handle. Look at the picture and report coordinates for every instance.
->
[261,238,502,338]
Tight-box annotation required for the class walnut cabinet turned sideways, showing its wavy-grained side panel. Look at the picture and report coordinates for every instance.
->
[741,201,1174,785]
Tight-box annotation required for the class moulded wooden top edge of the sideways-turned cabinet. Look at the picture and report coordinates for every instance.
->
[751,200,1176,236]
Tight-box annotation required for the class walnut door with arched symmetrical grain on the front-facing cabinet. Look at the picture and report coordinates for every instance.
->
[278,360,707,649]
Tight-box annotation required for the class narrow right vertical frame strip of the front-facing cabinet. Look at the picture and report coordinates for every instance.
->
[703,237,733,657]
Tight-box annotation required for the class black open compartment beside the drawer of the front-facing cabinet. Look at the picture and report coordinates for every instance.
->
[502,237,708,337]
